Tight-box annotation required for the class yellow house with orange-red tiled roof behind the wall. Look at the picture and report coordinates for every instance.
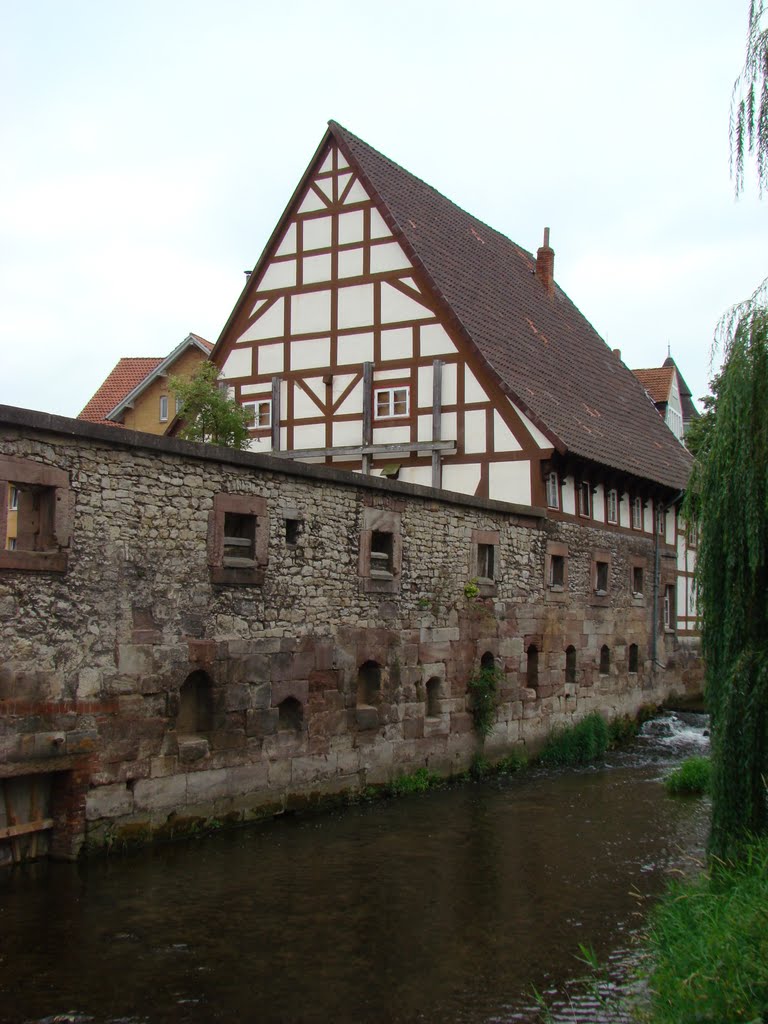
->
[78,334,213,434]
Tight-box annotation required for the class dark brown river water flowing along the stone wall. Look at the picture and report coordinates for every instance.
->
[0,715,708,1024]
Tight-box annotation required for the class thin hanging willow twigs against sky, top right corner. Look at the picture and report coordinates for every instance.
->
[730,0,768,196]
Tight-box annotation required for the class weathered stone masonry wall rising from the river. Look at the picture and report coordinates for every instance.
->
[0,409,698,856]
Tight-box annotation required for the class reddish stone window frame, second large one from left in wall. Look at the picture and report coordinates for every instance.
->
[208,493,269,587]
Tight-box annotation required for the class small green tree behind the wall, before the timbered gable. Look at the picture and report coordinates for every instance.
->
[169,362,249,451]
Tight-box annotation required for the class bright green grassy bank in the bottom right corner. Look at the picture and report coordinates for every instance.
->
[644,839,768,1024]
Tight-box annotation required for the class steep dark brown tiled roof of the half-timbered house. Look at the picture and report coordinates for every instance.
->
[329,121,691,487]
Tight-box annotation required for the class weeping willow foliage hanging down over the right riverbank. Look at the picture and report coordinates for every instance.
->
[687,300,768,859]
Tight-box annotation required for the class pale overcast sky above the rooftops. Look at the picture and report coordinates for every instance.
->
[0,0,768,416]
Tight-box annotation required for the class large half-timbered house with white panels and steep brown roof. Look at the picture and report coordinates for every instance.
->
[211,121,690,542]
